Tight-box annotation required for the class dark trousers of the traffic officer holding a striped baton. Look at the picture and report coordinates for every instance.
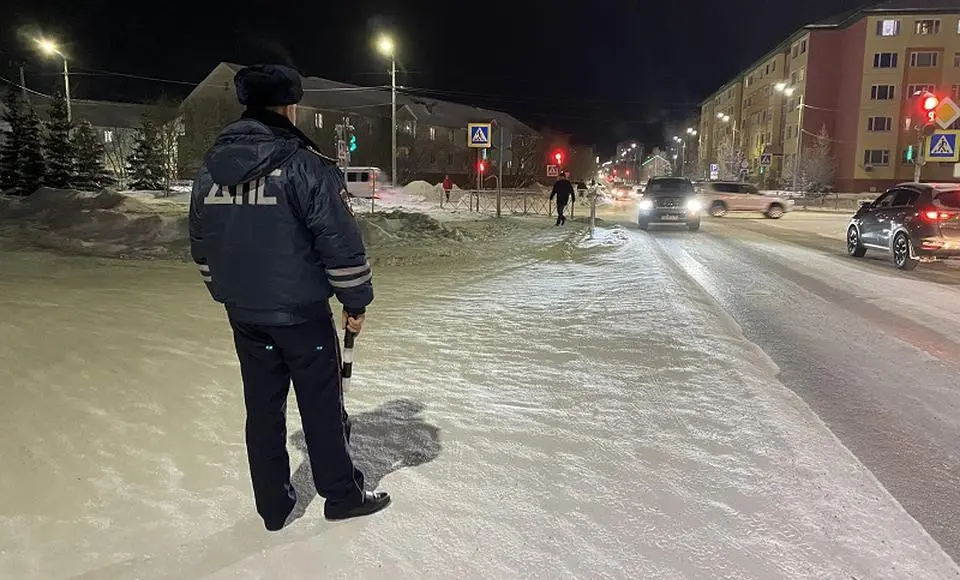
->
[230,317,363,523]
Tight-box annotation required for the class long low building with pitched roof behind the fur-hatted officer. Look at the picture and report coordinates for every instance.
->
[180,63,546,188]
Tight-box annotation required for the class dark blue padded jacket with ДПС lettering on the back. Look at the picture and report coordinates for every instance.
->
[190,111,373,326]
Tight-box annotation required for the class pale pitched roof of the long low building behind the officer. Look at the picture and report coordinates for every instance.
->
[198,63,534,133]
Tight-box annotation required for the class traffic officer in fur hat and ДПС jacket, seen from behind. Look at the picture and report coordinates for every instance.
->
[190,65,390,531]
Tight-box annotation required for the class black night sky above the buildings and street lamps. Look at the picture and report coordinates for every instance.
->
[0,0,863,150]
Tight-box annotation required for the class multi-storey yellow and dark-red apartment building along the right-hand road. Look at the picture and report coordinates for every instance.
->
[700,0,960,191]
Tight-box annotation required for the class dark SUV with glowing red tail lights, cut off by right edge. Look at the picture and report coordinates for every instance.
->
[847,183,960,270]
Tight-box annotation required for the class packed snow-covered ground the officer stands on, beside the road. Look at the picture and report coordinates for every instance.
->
[0,219,960,580]
